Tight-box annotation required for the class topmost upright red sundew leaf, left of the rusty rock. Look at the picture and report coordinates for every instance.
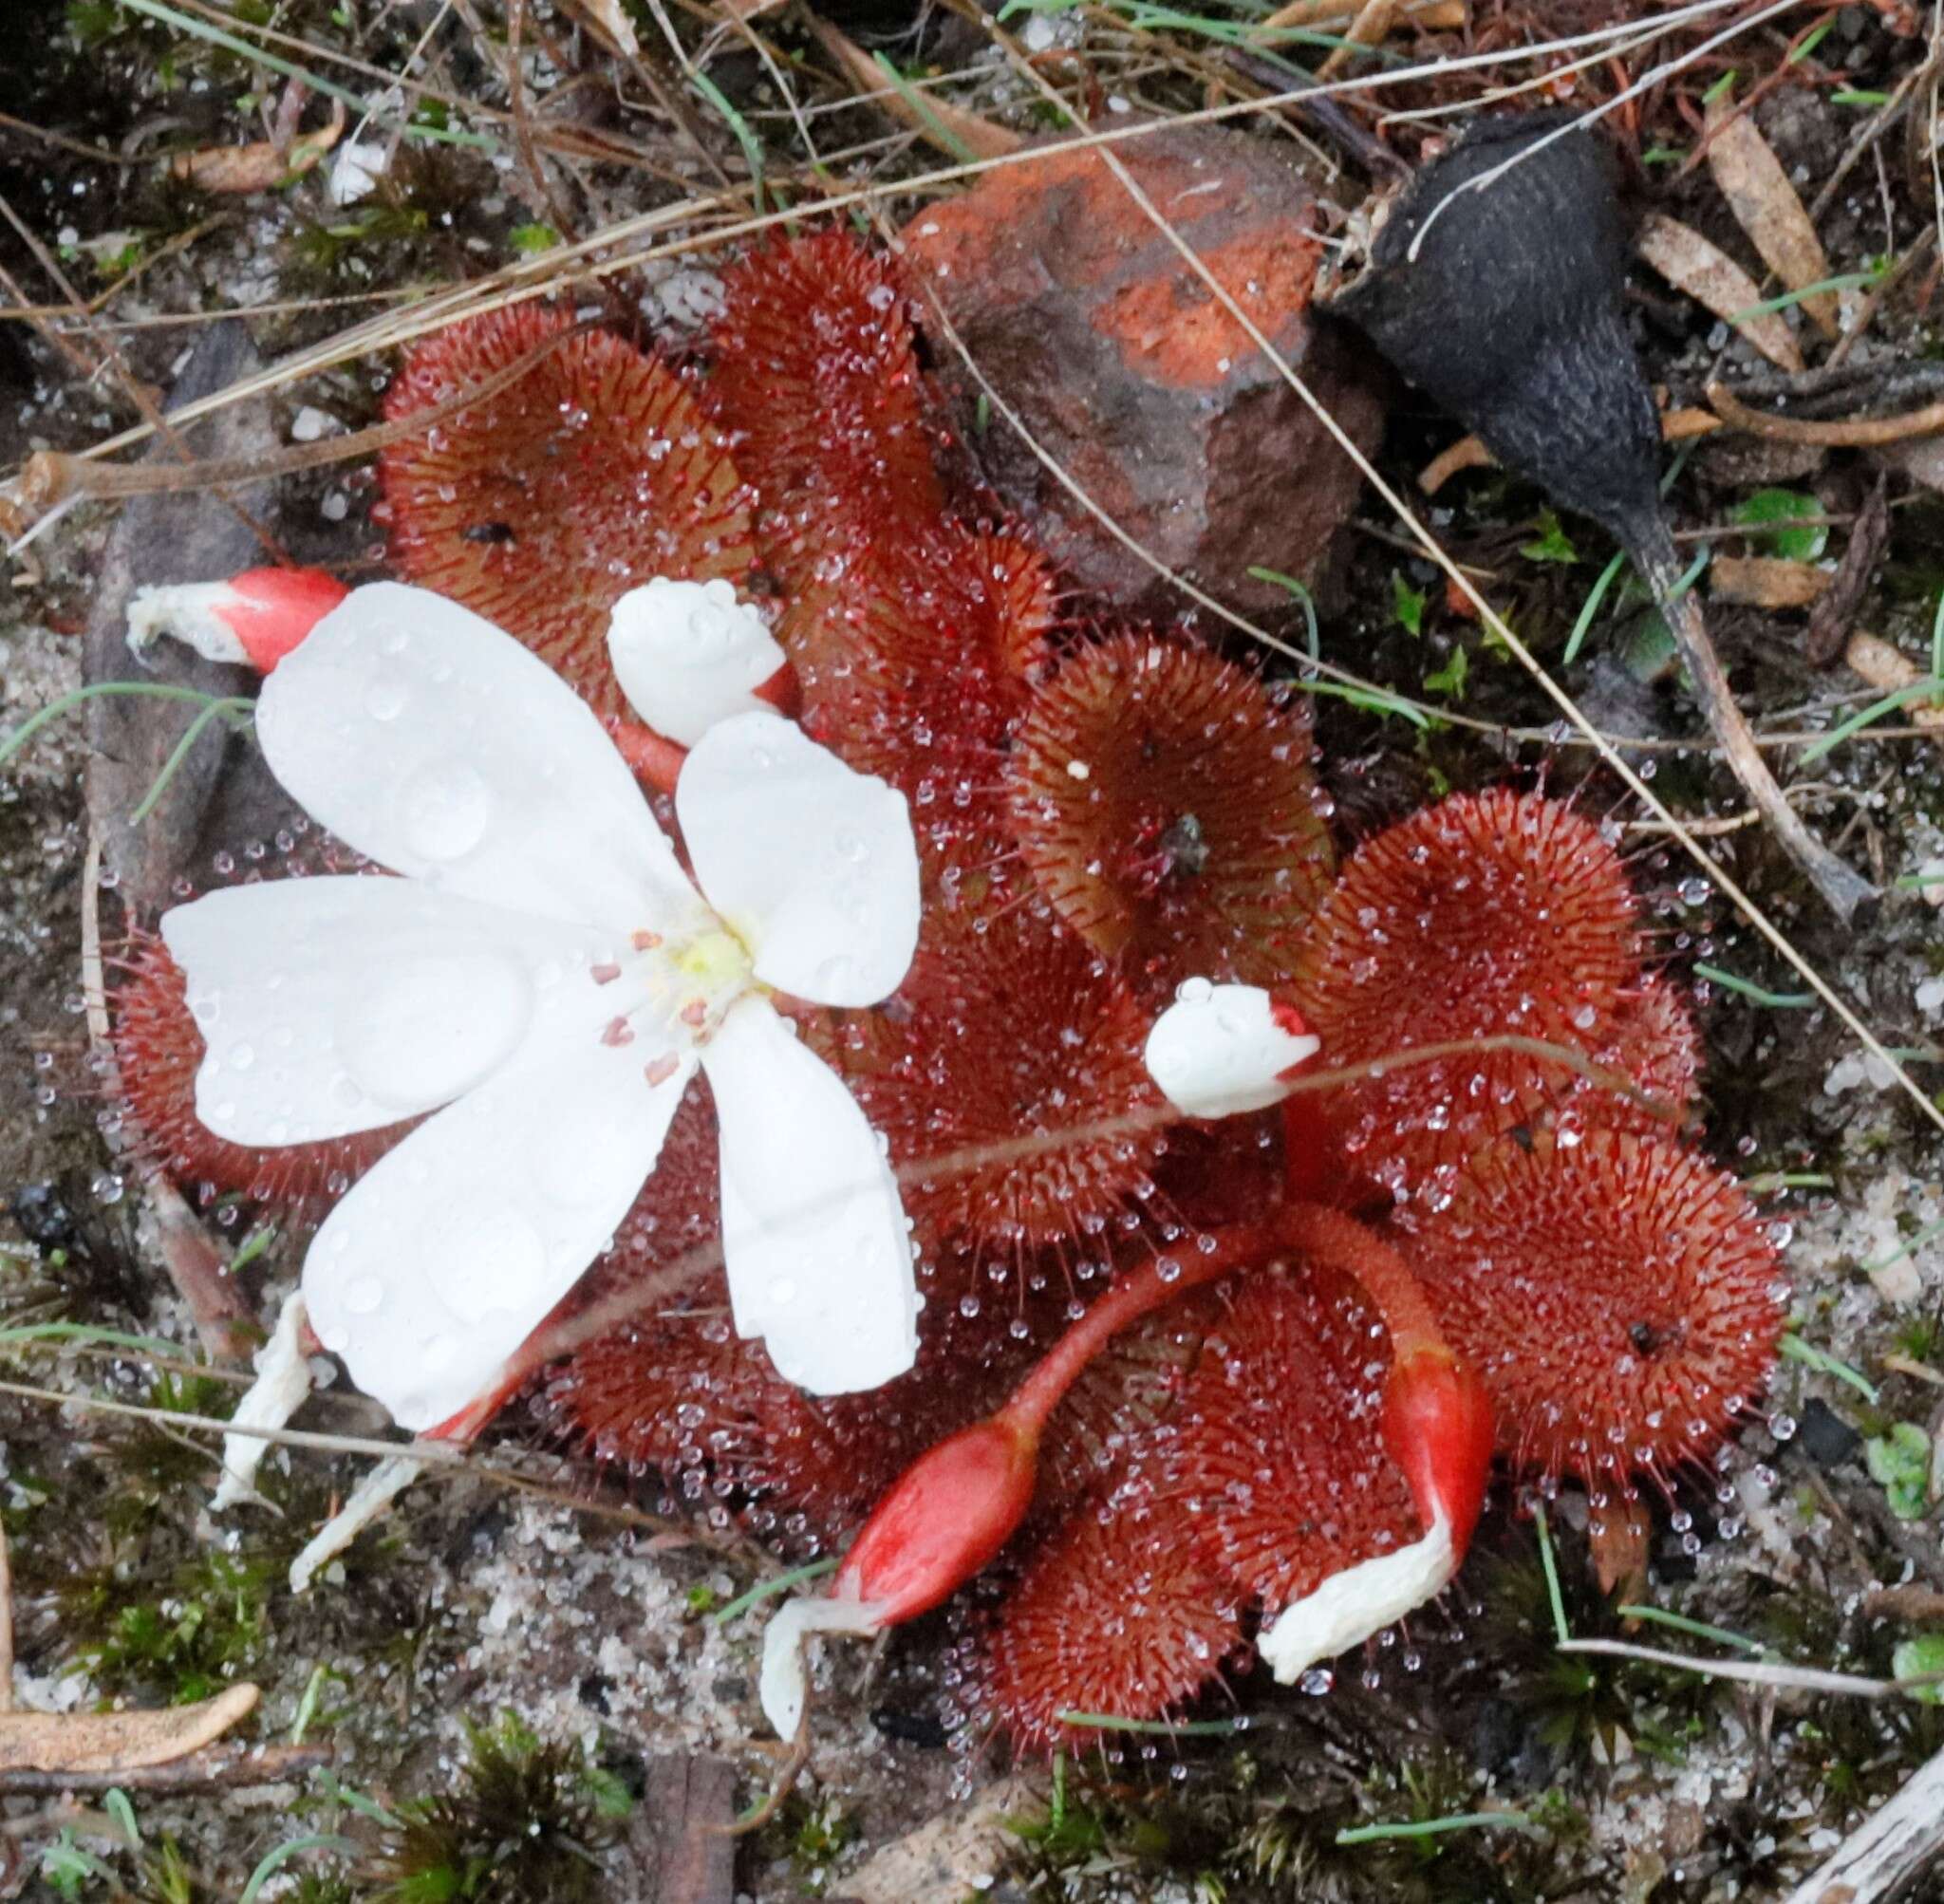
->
[705,230,944,588]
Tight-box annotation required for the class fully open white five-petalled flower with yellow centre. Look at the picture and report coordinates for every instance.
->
[161,584,918,1429]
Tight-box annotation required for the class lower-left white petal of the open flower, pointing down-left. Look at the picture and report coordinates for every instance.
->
[303,1040,694,1429]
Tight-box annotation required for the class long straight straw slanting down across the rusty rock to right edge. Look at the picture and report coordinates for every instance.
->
[956,6,1944,1132]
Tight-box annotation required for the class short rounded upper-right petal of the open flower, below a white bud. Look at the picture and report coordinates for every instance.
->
[675,714,918,1005]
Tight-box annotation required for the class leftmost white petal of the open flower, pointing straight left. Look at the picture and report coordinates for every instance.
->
[161,875,624,1146]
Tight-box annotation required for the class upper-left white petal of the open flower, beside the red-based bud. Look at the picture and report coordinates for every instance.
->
[256,582,694,934]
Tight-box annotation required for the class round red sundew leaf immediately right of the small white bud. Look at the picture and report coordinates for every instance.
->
[1289,788,1638,1194]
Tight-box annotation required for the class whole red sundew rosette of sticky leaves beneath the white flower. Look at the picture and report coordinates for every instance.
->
[98,233,1781,1748]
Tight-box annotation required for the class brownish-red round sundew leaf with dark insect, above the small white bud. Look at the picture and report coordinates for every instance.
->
[1007,632,1332,990]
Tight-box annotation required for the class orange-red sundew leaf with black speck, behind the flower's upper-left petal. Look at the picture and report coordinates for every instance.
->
[379,304,755,719]
